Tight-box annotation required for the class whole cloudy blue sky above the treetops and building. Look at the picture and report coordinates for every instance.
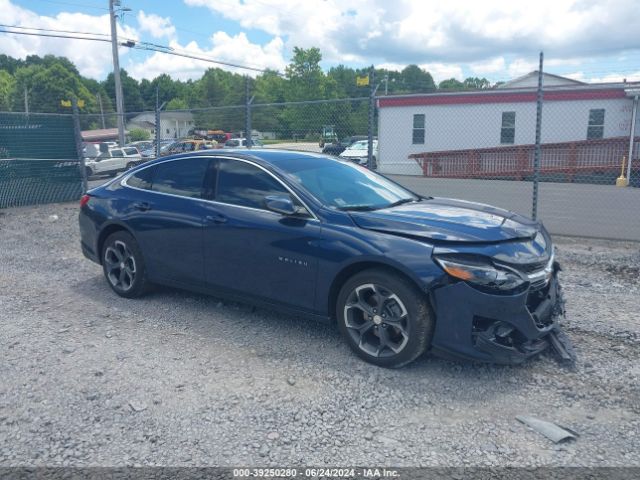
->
[0,0,640,82]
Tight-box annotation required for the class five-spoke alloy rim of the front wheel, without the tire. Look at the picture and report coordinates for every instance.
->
[344,283,409,357]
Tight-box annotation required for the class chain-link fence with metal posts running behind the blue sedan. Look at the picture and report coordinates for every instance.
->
[0,56,640,241]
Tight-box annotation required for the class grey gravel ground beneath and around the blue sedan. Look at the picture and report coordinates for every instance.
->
[0,204,640,466]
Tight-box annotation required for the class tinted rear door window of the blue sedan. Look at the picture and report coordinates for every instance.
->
[151,158,210,198]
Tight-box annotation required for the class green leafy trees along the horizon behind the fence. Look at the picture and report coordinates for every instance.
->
[0,47,491,136]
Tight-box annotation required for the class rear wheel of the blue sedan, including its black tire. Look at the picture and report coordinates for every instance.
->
[101,231,149,298]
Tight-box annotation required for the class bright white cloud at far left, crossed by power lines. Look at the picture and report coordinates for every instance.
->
[0,0,138,78]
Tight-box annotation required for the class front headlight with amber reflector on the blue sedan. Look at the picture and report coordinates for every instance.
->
[433,256,527,290]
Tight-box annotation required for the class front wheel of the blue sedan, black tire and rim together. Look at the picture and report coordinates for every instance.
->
[336,268,435,368]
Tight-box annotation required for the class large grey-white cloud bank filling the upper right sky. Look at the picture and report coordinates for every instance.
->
[184,0,640,68]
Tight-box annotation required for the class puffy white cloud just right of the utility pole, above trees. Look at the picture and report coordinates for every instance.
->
[127,32,286,80]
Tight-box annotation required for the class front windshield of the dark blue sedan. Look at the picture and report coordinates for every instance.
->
[277,158,420,210]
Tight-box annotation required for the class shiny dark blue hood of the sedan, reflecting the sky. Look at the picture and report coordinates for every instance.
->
[349,198,540,243]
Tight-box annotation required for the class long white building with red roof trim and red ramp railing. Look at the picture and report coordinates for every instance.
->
[378,72,640,177]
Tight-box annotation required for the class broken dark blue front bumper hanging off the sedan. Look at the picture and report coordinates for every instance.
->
[431,264,575,364]
